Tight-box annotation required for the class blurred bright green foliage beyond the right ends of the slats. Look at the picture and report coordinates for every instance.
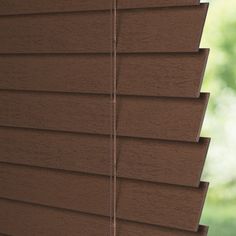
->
[201,0,236,236]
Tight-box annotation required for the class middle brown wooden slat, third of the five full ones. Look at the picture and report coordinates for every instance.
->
[0,91,209,142]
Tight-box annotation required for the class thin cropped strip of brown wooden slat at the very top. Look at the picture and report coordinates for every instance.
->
[0,0,200,15]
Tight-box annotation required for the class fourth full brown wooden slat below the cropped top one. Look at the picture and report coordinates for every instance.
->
[0,128,209,187]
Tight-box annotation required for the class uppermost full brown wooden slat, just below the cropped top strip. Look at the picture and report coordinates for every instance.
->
[0,4,208,53]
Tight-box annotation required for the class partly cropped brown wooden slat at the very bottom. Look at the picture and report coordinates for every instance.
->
[0,199,207,236]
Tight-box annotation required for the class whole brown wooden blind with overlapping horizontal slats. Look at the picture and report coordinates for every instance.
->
[0,0,210,236]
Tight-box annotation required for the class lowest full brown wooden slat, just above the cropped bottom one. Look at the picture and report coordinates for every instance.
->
[0,163,208,231]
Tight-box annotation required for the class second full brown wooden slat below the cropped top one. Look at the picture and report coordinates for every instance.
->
[0,49,209,97]
